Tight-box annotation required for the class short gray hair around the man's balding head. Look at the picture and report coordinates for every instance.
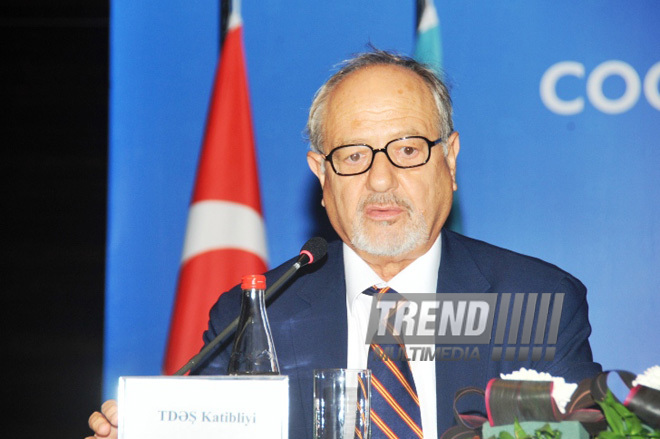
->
[306,50,454,155]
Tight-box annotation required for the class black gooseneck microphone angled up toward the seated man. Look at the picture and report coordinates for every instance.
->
[174,236,328,376]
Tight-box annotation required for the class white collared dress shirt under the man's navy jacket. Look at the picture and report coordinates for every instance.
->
[343,237,441,439]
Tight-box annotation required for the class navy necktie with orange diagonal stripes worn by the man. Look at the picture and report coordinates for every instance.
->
[364,287,423,439]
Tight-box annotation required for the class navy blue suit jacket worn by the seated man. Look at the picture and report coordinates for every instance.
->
[194,230,601,439]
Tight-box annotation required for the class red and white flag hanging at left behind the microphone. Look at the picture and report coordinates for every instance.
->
[164,12,267,375]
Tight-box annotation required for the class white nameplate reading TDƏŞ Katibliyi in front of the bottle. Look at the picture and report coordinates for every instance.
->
[118,375,289,439]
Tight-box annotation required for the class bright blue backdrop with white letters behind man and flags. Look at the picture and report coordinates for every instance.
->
[104,0,660,396]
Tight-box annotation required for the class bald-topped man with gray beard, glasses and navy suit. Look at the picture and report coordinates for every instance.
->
[85,51,600,438]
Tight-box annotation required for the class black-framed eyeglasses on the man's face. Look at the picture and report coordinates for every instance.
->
[323,136,442,175]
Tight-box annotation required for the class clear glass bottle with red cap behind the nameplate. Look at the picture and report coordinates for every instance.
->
[227,274,280,375]
